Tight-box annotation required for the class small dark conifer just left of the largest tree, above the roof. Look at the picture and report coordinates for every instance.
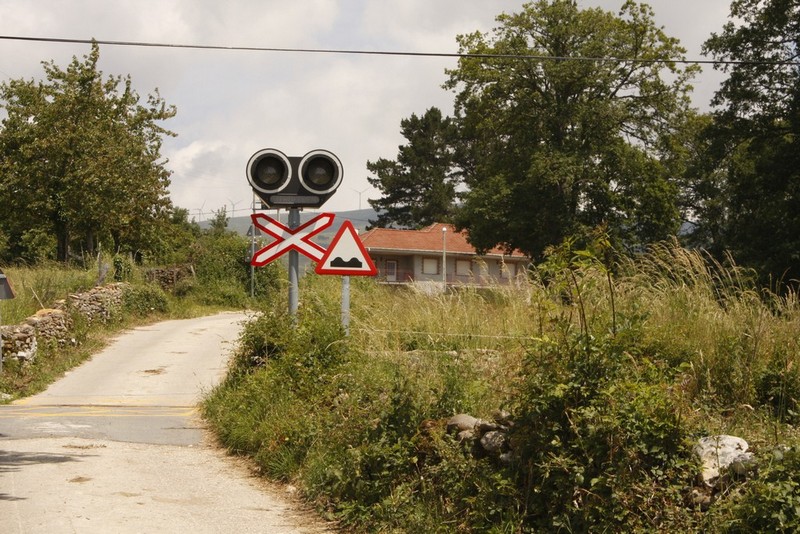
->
[367,107,458,228]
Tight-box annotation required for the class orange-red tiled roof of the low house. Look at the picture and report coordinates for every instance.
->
[358,223,527,259]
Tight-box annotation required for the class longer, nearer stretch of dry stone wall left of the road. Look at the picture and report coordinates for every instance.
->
[0,283,129,368]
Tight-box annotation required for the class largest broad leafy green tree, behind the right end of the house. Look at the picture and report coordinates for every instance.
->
[445,0,696,257]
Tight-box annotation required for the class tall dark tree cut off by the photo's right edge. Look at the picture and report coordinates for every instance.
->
[704,0,800,280]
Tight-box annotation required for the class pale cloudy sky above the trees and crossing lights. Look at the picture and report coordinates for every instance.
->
[0,0,730,221]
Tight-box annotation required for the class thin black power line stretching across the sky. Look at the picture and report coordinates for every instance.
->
[0,35,800,66]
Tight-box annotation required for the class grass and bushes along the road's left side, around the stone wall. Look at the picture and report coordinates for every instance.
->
[0,222,285,401]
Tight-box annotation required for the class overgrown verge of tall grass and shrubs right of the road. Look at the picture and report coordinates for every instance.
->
[204,243,800,532]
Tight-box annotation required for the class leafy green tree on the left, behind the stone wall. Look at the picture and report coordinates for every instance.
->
[0,43,175,261]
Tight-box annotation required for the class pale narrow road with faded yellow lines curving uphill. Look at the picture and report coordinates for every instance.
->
[0,313,326,534]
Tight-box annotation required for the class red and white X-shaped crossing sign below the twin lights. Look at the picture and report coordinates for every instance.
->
[250,213,334,267]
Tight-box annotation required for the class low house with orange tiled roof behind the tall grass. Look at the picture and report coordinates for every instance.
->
[359,223,530,285]
